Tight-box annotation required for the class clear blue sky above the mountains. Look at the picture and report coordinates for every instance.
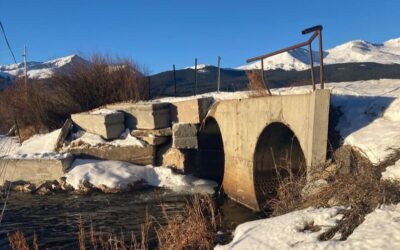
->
[0,0,400,73]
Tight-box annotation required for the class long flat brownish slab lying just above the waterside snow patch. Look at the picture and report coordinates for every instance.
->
[68,144,155,165]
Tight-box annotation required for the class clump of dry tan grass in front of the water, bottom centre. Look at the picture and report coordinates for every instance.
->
[157,195,218,249]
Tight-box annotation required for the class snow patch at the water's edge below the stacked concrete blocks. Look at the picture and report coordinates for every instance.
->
[66,159,217,193]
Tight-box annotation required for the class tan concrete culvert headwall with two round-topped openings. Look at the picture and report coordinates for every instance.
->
[199,90,330,210]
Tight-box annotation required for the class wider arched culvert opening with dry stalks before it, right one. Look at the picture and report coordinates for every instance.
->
[253,122,306,209]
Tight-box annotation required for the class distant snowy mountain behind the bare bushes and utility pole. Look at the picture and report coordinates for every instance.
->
[0,55,86,79]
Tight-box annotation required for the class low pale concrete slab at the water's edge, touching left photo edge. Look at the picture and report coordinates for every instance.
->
[0,156,74,185]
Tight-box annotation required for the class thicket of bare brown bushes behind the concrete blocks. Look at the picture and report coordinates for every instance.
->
[0,56,148,139]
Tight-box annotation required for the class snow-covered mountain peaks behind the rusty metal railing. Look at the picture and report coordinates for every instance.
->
[238,38,400,71]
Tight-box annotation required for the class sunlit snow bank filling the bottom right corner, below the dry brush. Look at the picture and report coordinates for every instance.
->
[216,204,400,250]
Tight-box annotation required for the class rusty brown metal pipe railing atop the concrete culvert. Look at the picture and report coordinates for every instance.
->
[247,25,324,95]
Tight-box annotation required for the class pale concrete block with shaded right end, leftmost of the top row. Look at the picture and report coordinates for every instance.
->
[71,112,125,140]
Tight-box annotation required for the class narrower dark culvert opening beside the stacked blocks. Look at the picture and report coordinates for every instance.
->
[197,117,225,184]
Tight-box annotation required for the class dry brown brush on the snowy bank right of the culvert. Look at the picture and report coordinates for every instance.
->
[269,146,400,240]
